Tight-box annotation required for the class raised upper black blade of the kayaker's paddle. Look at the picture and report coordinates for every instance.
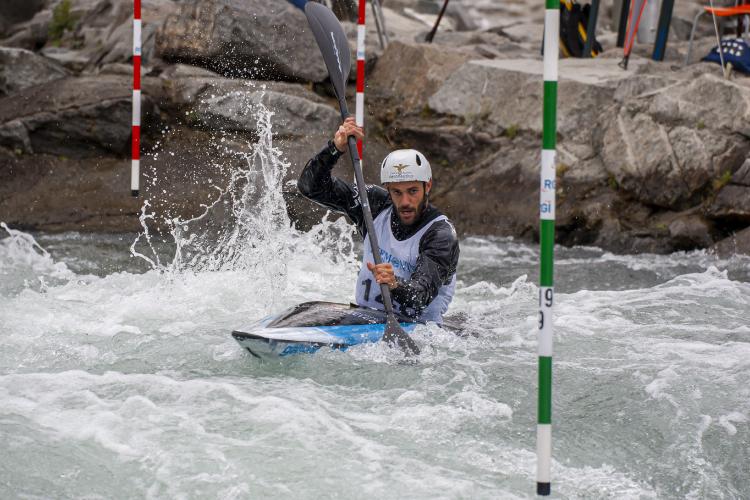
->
[305,2,351,100]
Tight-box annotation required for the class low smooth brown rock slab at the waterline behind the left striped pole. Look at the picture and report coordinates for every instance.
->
[0,129,245,232]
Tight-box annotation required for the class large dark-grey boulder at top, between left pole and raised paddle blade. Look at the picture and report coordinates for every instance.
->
[156,0,328,82]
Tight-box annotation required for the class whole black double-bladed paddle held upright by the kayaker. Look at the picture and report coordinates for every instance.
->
[305,2,419,355]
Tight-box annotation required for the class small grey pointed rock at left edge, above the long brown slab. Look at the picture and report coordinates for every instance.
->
[0,47,68,97]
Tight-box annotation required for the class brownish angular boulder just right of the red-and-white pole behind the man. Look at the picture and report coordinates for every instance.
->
[367,41,477,114]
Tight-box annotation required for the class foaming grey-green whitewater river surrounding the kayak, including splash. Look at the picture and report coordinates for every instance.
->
[0,104,750,499]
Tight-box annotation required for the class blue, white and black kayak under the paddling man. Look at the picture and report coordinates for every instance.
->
[232,302,419,359]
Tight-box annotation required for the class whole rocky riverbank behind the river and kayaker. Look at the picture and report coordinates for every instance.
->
[0,0,750,253]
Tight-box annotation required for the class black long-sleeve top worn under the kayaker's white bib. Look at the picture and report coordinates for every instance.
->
[297,141,459,314]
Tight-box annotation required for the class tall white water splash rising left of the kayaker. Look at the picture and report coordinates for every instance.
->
[130,96,356,308]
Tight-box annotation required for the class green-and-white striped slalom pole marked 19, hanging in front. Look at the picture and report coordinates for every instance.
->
[536,0,560,495]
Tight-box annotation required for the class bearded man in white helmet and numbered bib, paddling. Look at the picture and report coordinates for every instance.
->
[297,117,459,324]
